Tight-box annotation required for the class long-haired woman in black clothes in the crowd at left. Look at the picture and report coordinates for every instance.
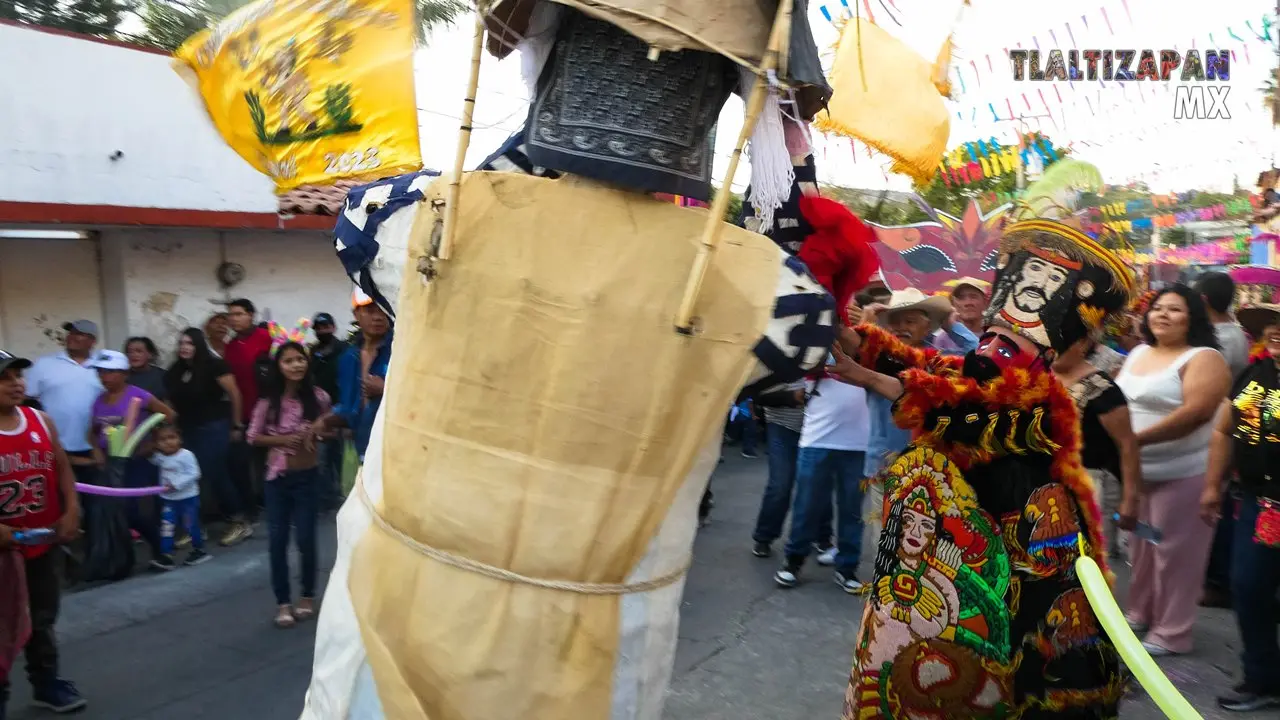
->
[165,328,244,544]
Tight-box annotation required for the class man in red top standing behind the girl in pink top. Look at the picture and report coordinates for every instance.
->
[219,297,271,546]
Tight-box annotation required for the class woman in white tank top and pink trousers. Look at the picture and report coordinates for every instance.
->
[1116,284,1231,656]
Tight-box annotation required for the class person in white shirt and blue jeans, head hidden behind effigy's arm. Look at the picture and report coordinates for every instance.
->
[773,360,870,593]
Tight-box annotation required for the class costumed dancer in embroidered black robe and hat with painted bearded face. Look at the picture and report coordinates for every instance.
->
[837,220,1134,720]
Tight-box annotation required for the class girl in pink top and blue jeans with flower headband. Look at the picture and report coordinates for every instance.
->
[248,342,330,628]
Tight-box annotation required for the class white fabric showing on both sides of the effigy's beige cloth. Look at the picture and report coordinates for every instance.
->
[300,382,724,720]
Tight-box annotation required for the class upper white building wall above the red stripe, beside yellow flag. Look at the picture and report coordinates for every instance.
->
[0,24,276,214]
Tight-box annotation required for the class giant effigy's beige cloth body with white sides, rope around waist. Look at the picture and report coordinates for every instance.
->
[303,173,780,720]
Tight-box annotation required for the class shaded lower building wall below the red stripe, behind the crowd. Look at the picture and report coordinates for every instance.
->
[0,228,352,363]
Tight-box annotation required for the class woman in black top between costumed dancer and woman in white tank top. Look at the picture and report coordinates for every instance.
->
[1053,337,1142,557]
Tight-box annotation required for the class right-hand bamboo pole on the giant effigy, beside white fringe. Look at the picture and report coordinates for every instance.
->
[675,0,792,334]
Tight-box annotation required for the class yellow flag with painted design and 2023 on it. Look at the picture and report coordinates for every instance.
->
[175,0,422,193]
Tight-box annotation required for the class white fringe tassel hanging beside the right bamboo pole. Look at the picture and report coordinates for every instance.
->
[739,68,796,234]
